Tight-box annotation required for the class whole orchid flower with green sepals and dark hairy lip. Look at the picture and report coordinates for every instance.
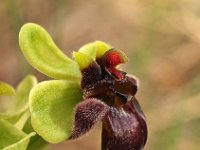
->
[19,23,147,150]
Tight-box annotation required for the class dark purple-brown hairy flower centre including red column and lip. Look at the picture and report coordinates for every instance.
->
[71,49,147,150]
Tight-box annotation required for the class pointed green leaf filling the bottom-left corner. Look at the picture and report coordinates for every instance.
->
[0,119,35,150]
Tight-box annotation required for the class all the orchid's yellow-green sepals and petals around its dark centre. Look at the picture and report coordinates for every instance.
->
[19,23,111,143]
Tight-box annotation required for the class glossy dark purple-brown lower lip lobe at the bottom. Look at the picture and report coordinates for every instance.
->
[102,97,147,150]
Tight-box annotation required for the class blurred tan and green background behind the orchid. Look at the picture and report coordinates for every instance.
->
[0,0,200,150]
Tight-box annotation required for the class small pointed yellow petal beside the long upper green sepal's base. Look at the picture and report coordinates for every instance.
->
[73,52,93,70]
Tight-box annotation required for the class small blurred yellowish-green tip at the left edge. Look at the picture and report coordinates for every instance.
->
[0,81,15,96]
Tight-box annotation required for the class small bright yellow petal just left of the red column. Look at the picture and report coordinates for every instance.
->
[95,41,113,58]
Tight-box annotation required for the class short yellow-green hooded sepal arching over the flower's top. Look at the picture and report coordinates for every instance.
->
[79,41,112,60]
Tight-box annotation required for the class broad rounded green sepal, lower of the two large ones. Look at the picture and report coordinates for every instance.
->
[29,80,82,143]
